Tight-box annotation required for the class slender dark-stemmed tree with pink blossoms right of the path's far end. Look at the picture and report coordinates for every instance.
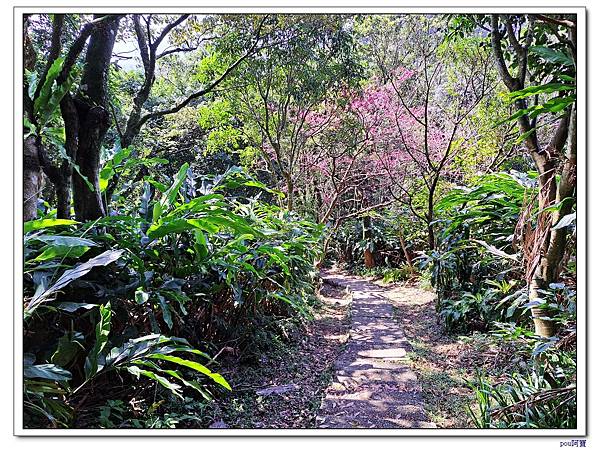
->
[357,16,495,249]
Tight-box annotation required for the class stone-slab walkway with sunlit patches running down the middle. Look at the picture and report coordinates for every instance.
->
[316,271,435,428]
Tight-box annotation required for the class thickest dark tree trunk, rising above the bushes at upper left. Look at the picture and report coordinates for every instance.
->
[65,16,119,221]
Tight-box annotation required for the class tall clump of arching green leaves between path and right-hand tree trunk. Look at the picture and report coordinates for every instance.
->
[421,173,535,331]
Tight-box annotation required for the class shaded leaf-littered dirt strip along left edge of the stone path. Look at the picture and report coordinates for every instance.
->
[205,276,351,428]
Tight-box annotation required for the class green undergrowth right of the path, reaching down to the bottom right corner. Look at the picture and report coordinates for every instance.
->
[422,173,576,428]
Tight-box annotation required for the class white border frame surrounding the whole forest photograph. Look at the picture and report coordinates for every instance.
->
[13,2,589,438]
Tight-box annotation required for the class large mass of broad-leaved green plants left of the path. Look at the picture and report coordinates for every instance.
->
[24,161,320,427]
